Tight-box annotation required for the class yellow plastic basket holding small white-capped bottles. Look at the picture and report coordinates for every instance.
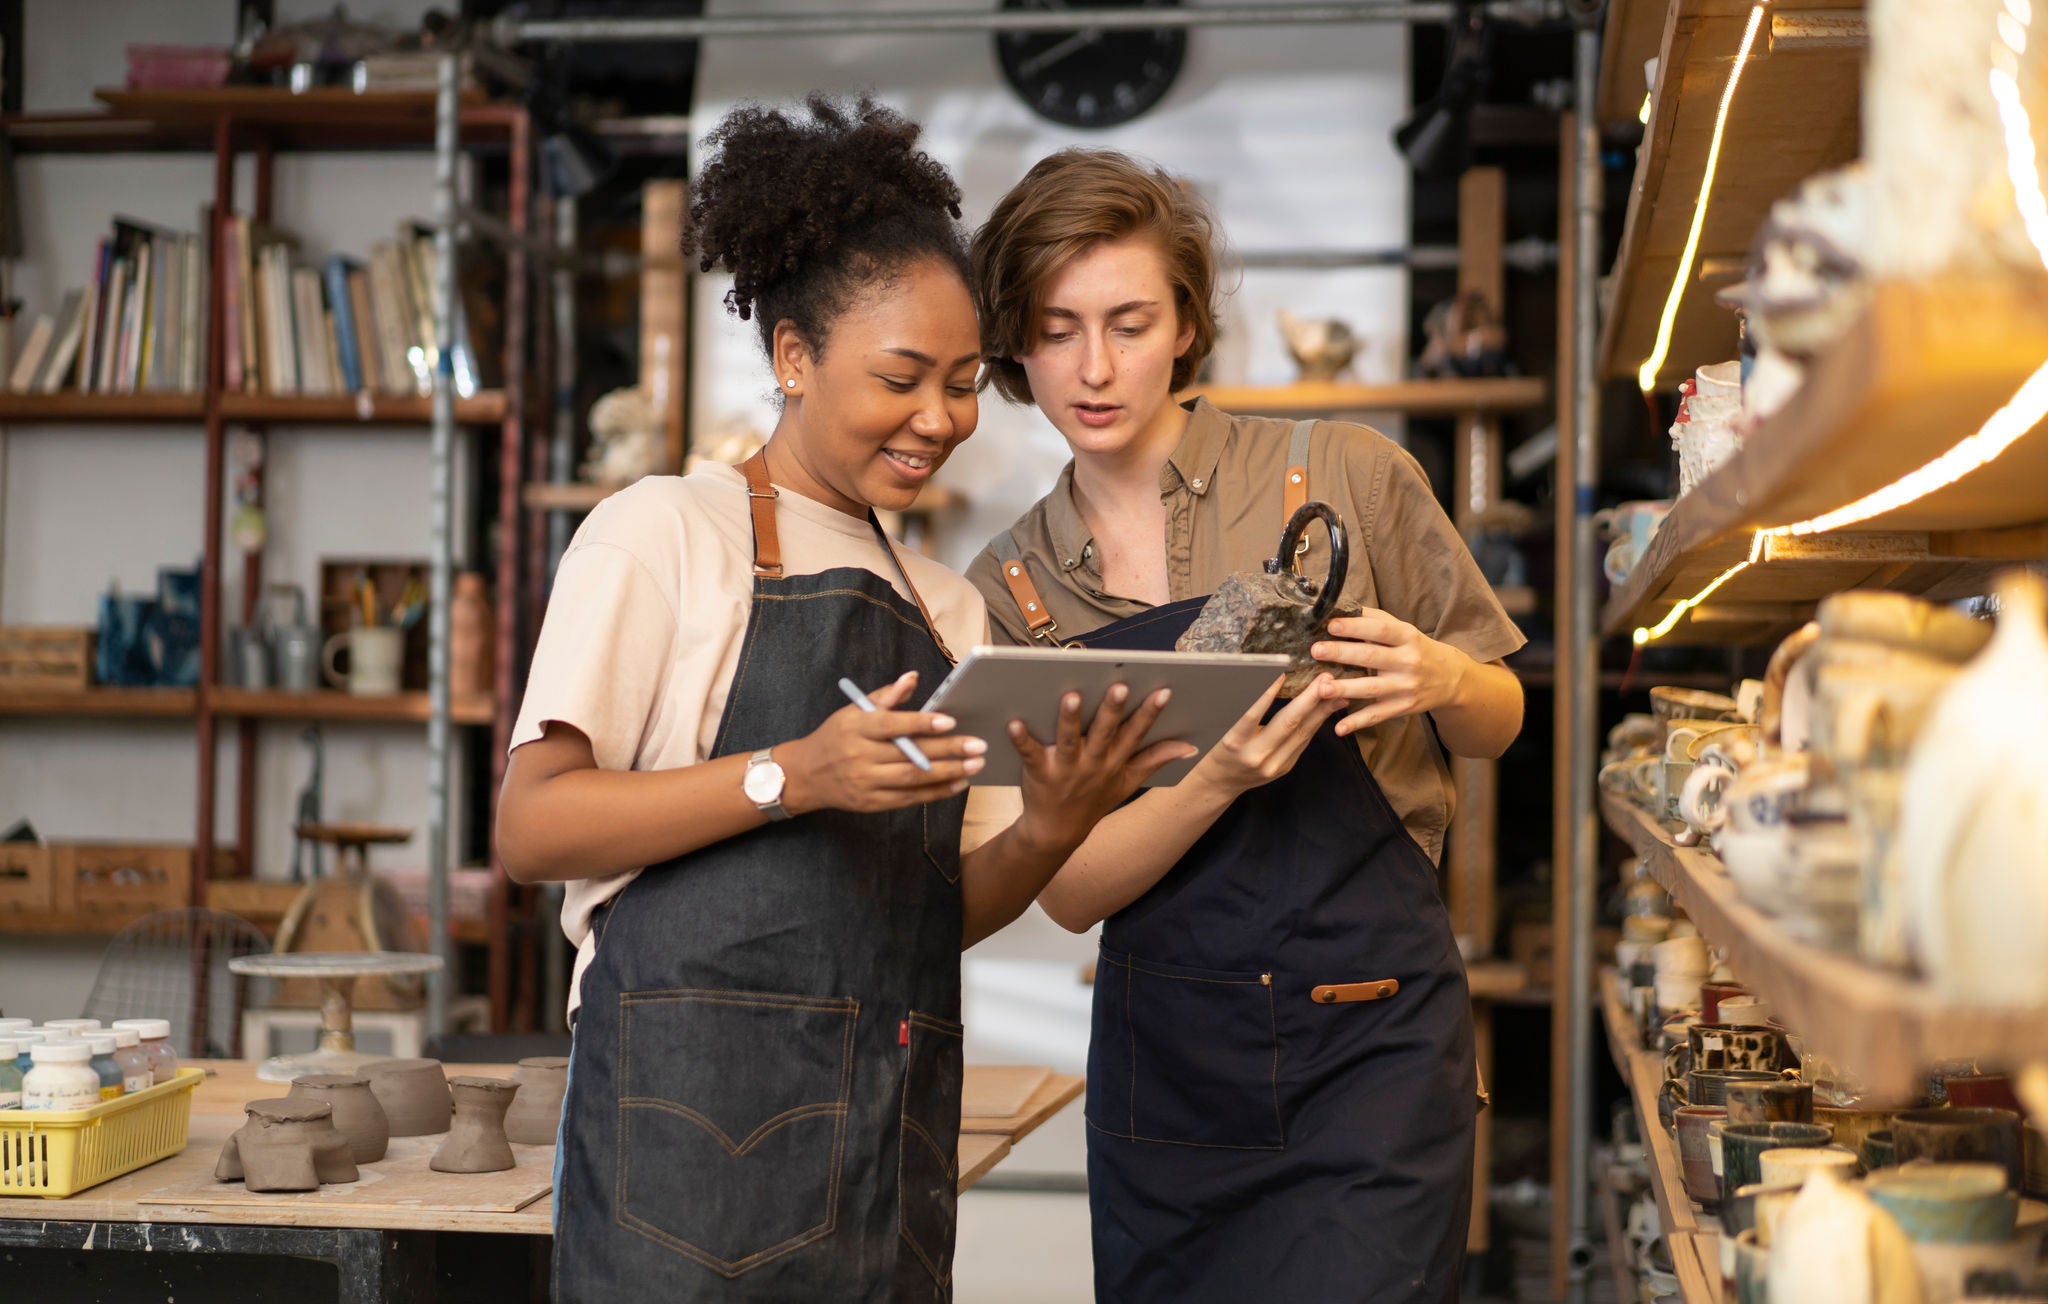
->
[0,1069,207,1200]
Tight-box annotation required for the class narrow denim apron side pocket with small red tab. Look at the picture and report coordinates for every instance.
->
[897,1011,961,1290]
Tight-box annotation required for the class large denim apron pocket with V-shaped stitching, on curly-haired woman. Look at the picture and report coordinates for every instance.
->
[618,991,860,1277]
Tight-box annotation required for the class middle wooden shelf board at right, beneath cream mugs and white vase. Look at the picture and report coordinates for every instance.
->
[1602,794,2048,1097]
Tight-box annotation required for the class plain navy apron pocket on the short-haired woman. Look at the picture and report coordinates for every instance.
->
[1090,948,1286,1150]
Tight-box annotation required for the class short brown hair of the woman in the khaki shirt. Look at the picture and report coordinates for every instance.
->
[973,149,1217,403]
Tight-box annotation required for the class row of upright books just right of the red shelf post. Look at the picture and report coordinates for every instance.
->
[221,213,477,397]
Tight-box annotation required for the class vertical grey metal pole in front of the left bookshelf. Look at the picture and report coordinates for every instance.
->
[426,53,461,1036]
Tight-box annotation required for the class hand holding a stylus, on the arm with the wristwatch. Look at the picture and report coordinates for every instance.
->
[770,669,989,815]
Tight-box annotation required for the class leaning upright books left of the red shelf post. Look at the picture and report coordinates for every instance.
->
[8,209,213,393]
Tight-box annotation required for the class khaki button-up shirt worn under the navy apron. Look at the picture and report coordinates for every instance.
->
[967,399,1526,860]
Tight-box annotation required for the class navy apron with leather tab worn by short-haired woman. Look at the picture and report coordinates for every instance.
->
[997,424,1479,1304]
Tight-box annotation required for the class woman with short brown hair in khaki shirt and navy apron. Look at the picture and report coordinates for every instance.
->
[969,149,1522,1304]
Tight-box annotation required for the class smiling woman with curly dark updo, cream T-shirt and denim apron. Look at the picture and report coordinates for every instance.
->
[498,98,1188,1304]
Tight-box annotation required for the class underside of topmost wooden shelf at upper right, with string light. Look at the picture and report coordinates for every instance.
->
[1599,0,1864,389]
